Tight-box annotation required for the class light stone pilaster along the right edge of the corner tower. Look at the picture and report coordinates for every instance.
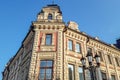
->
[56,31,63,80]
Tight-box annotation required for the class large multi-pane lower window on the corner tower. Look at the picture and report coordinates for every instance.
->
[39,60,53,80]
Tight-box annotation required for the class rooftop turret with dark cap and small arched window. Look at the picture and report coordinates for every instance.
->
[37,4,62,22]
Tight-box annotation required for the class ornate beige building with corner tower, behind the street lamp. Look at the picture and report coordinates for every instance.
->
[2,4,120,80]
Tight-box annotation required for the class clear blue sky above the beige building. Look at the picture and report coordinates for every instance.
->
[0,0,120,80]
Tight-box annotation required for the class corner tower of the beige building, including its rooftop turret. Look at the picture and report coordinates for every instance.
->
[29,4,65,80]
